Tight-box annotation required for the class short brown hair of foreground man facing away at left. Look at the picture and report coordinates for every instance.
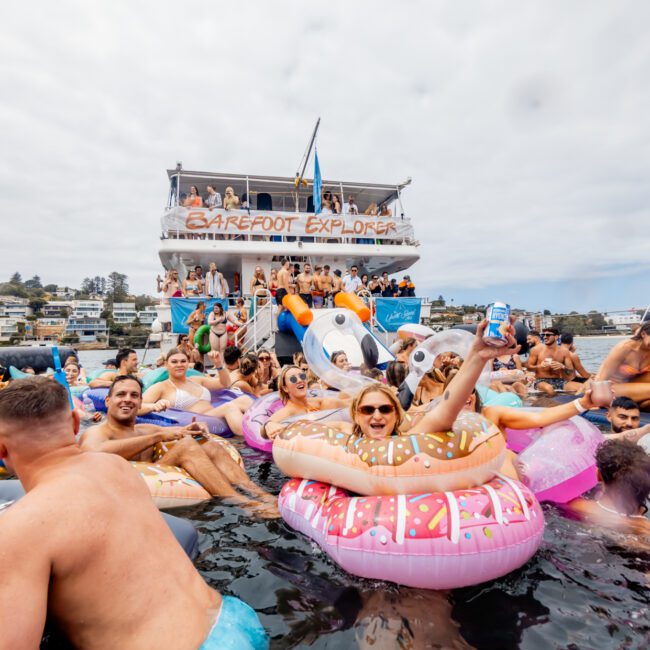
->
[0,377,70,426]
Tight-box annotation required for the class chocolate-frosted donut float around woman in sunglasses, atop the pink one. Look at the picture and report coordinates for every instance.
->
[273,412,506,495]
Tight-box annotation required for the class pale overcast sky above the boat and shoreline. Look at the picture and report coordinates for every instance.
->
[0,0,650,311]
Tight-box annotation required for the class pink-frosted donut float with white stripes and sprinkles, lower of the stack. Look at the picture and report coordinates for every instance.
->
[279,476,544,589]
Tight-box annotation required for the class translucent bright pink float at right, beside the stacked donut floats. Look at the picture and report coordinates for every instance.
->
[508,416,605,503]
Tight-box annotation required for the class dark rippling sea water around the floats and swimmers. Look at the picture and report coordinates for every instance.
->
[49,338,650,650]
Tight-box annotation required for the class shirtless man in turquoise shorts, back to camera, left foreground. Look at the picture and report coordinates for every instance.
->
[0,377,268,650]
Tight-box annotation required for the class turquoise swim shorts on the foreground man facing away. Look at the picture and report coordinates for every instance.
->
[199,596,269,650]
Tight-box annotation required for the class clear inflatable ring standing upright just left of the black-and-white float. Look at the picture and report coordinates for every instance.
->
[302,309,379,395]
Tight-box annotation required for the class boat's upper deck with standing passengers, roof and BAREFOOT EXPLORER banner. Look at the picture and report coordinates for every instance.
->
[162,166,418,246]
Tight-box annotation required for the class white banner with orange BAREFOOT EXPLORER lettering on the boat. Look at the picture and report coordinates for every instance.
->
[162,207,413,239]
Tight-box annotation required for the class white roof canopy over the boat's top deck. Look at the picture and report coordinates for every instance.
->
[167,169,411,213]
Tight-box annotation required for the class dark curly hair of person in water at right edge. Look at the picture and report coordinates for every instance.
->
[596,440,650,513]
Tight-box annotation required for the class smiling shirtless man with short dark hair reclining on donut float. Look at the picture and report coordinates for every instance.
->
[79,375,277,515]
